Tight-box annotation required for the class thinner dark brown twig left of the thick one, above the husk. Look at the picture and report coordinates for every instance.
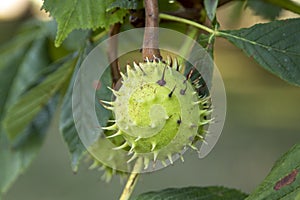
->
[108,23,121,88]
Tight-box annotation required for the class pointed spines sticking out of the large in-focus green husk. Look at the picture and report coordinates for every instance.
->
[100,57,212,169]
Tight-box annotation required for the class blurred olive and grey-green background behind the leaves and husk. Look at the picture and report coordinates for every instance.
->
[0,0,300,200]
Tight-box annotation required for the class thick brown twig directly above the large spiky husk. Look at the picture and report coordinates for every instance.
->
[143,0,162,61]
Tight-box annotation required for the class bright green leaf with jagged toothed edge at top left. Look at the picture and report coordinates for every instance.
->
[42,0,127,47]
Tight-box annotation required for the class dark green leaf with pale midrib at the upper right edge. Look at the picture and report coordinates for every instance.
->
[217,18,300,86]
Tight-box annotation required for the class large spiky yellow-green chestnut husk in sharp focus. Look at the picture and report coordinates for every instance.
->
[102,58,210,168]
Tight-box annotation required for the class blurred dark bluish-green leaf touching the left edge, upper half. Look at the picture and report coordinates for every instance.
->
[0,22,49,123]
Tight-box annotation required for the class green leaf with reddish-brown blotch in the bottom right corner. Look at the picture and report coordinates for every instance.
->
[247,144,300,200]
